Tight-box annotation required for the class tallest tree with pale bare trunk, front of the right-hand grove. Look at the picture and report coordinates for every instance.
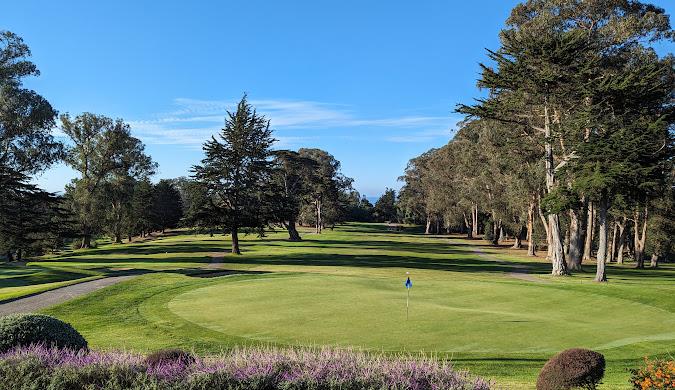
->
[459,0,672,275]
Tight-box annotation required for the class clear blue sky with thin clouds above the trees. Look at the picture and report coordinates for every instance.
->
[0,0,675,196]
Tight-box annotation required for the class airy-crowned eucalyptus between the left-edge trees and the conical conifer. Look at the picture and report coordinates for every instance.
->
[61,113,156,248]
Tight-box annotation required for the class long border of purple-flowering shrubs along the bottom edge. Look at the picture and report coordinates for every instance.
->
[0,345,491,390]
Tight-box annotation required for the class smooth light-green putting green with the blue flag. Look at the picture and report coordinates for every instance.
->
[168,274,675,355]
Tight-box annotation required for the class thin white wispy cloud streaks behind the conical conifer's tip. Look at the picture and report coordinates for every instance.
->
[130,98,456,147]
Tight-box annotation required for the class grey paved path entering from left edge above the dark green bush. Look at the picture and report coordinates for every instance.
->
[0,275,137,316]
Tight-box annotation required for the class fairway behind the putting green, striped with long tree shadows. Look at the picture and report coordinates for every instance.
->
[17,223,675,283]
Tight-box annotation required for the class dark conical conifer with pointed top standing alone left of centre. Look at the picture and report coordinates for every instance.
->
[193,95,274,254]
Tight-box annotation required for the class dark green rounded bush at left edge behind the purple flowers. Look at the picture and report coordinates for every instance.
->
[0,314,87,352]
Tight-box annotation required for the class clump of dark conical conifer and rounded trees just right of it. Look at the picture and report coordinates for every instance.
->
[179,96,380,254]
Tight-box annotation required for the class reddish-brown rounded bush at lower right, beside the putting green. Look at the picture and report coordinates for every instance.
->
[537,348,605,390]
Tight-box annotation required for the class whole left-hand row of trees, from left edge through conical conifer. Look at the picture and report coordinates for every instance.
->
[0,31,380,261]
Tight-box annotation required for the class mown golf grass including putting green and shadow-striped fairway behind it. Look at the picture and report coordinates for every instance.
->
[21,224,675,389]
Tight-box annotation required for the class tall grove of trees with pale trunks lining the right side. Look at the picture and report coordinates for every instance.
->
[399,0,675,281]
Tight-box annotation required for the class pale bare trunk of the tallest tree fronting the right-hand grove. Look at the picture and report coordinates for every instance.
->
[544,103,569,276]
